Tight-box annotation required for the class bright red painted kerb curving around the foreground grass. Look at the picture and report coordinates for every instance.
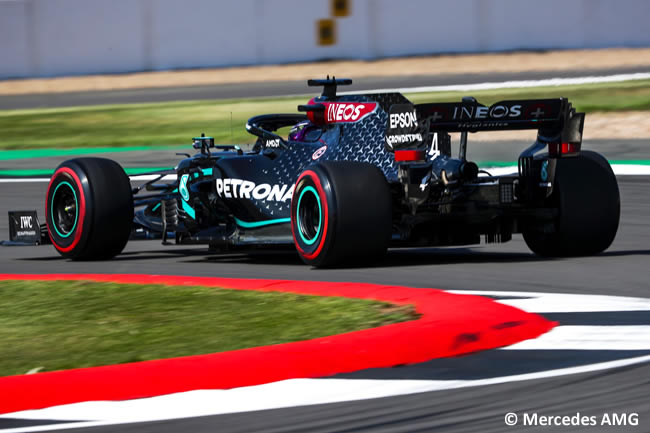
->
[0,274,557,413]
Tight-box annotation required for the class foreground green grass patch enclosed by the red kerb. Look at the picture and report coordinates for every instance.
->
[0,281,416,376]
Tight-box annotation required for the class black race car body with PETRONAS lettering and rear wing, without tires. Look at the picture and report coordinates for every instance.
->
[134,80,584,248]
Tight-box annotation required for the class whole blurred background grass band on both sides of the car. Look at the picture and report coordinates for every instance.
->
[0,80,650,149]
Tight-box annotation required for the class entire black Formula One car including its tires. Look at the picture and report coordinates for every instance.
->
[39,78,620,266]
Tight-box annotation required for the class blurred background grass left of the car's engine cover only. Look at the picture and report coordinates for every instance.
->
[0,98,305,150]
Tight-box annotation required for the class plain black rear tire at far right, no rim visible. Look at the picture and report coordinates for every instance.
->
[523,151,620,257]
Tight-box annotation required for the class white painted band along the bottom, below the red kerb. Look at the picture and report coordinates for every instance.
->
[5,355,650,433]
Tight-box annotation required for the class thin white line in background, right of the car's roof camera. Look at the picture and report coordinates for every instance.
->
[346,72,650,95]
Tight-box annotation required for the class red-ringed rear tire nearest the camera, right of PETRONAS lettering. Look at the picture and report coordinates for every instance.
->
[291,161,392,267]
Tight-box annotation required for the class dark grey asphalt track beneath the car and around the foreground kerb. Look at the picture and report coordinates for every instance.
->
[0,176,650,432]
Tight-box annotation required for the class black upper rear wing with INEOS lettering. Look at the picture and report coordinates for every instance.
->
[414,97,585,143]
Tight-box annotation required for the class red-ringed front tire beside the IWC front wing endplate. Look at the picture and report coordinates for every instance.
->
[45,158,133,260]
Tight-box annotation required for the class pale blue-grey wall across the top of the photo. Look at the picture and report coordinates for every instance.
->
[0,0,650,78]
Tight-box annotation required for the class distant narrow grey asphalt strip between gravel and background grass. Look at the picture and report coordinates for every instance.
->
[5,64,648,110]
